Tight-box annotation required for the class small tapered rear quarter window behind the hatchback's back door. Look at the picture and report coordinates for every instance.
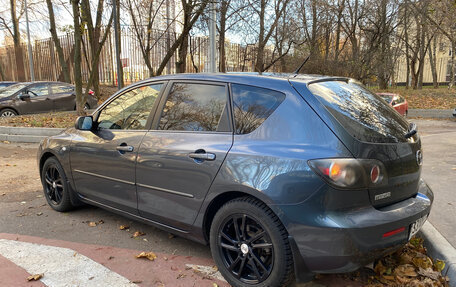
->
[231,84,285,134]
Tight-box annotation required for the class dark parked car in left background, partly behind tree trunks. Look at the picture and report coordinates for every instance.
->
[0,82,97,117]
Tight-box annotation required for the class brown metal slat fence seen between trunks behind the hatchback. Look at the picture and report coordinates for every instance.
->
[0,26,273,85]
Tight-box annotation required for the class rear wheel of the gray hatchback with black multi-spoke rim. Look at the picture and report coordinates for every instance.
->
[210,197,294,287]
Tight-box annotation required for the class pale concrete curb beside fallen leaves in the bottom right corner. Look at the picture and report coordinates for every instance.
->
[419,221,456,287]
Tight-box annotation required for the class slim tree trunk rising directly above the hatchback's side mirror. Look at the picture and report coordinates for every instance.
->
[71,0,86,116]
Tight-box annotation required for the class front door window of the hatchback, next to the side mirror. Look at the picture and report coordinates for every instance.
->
[98,84,163,130]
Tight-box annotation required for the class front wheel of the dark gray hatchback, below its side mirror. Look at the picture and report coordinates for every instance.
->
[41,157,73,212]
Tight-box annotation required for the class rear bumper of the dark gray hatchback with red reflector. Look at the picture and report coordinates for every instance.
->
[282,180,434,277]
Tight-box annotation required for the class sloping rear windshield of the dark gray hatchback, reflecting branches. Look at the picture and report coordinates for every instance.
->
[308,81,408,143]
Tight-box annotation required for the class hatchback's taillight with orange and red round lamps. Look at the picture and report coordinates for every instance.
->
[309,158,387,189]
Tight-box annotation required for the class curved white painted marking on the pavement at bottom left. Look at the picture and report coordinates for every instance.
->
[0,239,137,287]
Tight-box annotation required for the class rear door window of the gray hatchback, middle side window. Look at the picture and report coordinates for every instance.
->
[158,83,227,131]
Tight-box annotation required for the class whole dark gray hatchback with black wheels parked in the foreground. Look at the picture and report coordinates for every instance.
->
[38,74,433,286]
